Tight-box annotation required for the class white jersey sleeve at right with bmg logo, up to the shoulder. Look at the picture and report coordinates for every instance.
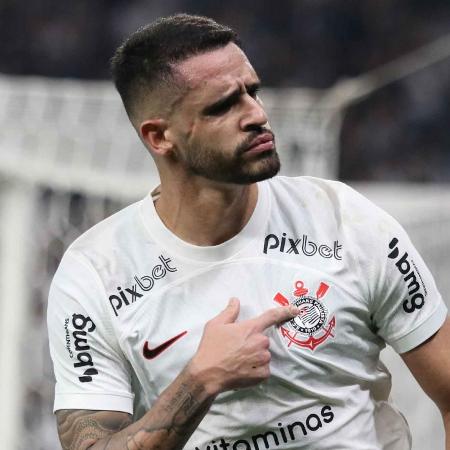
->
[342,185,447,353]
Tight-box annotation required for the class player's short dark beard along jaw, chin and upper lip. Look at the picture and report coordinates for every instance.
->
[180,130,281,184]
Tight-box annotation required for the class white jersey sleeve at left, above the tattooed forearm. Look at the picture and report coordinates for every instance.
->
[47,253,134,414]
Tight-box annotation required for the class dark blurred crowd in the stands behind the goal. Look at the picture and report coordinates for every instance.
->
[0,0,450,182]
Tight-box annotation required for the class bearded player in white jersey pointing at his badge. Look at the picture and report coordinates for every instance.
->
[48,15,450,450]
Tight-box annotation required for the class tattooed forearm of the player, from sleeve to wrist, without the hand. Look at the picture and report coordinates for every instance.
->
[59,368,214,450]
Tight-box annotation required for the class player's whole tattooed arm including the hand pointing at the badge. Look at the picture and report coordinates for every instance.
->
[57,299,298,450]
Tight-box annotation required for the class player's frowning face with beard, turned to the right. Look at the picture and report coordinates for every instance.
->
[163,44,280,184]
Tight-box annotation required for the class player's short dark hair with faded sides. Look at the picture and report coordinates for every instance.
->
[111,14,241,119]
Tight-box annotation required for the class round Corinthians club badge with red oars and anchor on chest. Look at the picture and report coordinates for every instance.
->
[274,281,336,351]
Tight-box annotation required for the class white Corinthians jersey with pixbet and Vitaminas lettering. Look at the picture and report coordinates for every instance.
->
[48,177,447,450]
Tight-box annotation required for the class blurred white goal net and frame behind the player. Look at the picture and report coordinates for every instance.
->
[0,32,450,450]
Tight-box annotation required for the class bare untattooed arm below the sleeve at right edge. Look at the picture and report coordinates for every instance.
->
[401,318,450,450]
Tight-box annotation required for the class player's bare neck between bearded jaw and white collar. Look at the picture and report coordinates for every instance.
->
[156,180,258,246]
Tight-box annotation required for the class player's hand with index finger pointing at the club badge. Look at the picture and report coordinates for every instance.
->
[187,298,299,395]
